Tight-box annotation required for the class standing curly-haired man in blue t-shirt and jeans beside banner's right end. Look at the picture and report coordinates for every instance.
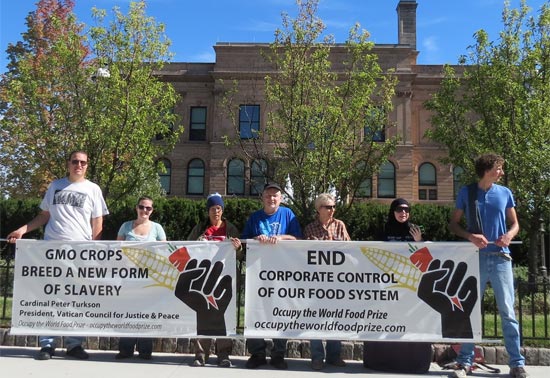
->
[449,154,528,378]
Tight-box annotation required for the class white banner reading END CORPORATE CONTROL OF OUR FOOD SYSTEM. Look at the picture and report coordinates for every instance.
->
[244,240,481,342]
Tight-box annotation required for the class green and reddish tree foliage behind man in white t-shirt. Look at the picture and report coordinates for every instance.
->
[0,0,181,199]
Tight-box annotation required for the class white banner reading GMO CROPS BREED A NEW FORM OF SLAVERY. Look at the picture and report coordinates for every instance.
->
[11,240,237,337]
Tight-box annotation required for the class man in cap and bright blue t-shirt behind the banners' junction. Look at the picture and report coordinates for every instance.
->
[242,184,302,369]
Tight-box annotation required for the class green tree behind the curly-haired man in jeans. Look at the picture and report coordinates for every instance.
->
[426,1,550,275]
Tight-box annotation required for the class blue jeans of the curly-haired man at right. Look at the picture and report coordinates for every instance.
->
[456,252,525,367]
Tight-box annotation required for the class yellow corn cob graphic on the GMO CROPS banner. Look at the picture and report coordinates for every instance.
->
[122,247,180,290]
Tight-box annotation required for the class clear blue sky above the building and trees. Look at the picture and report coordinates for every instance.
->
[0,0,548,72]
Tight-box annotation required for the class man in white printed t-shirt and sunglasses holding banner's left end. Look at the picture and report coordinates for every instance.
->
[7,151,109,360]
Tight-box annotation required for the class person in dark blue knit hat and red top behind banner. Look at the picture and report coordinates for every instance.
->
[187,193,243,367]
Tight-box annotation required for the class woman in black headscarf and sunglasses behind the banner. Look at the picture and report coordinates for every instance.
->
[383,198,423,242]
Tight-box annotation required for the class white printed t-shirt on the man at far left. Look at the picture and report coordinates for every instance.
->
[40,177,109,241]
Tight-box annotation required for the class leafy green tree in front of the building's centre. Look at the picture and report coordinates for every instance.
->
[219,0,396,221]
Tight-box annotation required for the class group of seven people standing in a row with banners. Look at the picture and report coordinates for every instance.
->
[7,151,528,378]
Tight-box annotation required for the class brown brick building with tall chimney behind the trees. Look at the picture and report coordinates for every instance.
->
[159,0,462,203]
